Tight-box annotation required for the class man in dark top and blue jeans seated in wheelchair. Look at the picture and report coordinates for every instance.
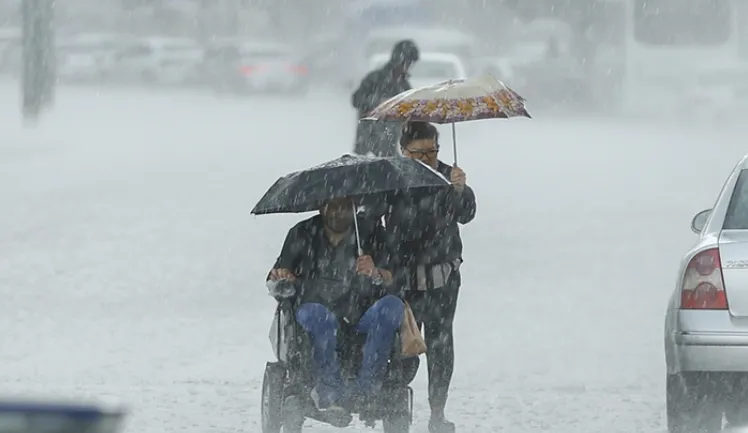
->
[268,199,405,413]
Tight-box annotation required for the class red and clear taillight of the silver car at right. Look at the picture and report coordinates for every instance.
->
[680,248,727,310]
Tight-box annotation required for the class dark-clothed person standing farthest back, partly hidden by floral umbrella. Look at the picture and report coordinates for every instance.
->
[351,40,419,156]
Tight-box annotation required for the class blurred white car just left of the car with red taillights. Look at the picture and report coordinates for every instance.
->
[117,37,205,85]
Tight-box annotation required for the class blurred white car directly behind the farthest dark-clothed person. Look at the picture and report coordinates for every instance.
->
[369,51,467,88]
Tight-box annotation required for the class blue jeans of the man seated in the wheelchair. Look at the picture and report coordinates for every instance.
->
[296,295,405,408]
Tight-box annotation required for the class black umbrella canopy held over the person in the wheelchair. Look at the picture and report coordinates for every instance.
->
[252,155,450,215]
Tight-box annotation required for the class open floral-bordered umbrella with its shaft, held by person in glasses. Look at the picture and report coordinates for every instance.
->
[361,74,531,165]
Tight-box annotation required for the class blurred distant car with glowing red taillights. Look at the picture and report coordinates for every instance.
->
[202,42,309,94]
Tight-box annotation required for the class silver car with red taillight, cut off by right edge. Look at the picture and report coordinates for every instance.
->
[665,155,748,433]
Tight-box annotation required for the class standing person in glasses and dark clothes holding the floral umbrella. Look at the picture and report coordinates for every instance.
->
[384,122,476,433]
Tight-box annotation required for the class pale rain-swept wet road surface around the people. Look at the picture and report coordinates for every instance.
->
[0,84,745,433]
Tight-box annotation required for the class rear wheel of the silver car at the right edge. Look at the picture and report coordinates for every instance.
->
[666,374,722,433]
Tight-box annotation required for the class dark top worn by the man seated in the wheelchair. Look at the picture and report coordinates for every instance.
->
[273,215,398,323]
